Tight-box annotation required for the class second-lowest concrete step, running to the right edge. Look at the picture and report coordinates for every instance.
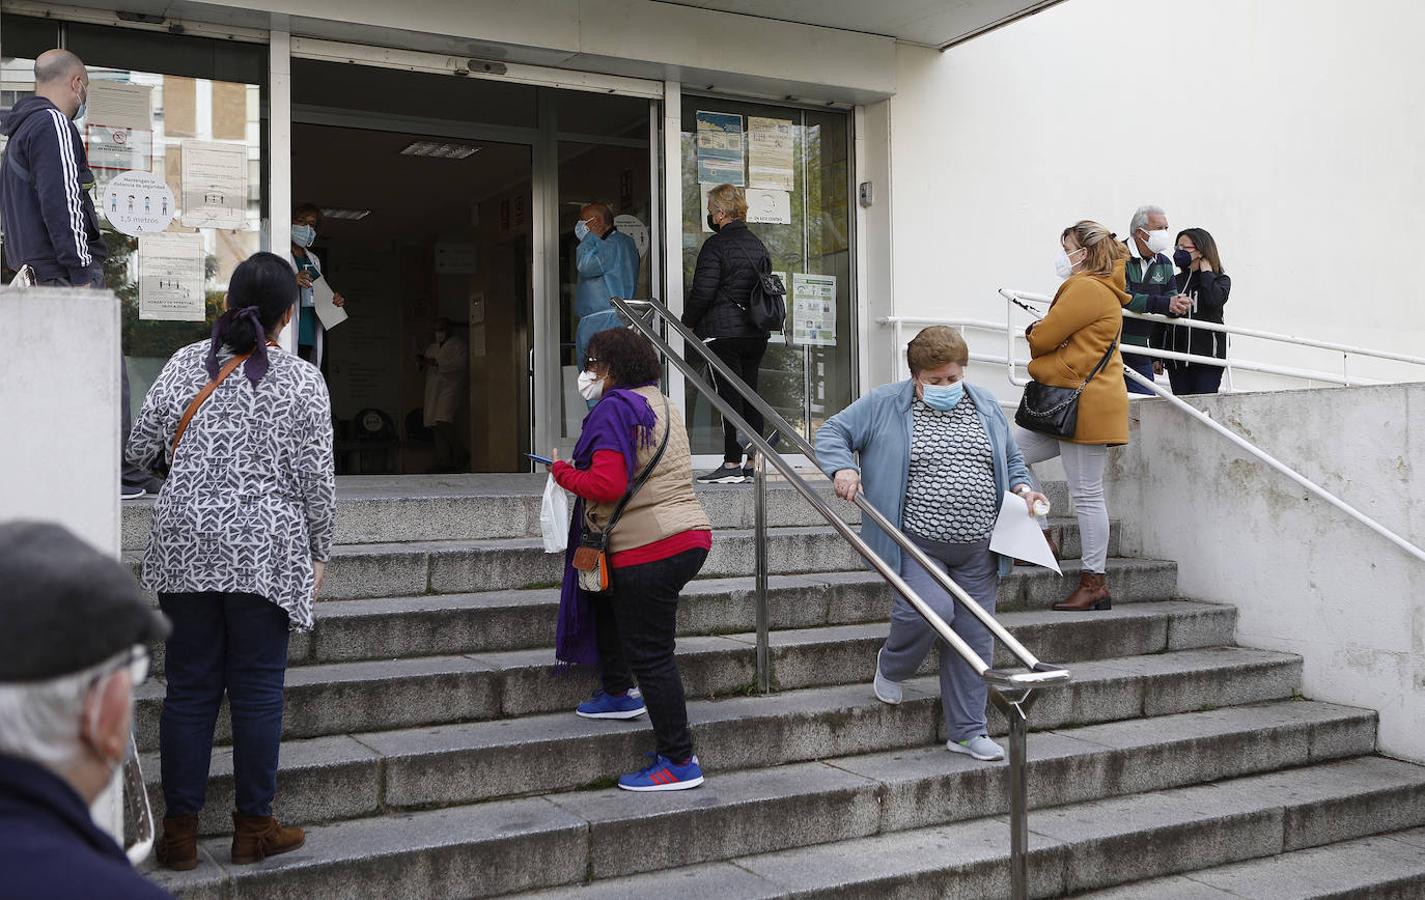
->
[530,756,1425,900]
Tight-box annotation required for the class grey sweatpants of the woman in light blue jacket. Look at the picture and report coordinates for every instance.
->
[881,535,999,741]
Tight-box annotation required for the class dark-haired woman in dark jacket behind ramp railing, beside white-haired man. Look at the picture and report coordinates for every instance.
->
[1160,228,1233,396]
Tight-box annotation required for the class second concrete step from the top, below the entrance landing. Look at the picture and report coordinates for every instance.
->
[124,520,1119,600]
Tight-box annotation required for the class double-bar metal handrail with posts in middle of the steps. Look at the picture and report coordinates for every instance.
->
[611,298,1070,900]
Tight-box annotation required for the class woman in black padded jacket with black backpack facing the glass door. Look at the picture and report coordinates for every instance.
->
[683,184,768,484]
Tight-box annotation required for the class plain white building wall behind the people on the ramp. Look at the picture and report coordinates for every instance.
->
[872,0,1425,387]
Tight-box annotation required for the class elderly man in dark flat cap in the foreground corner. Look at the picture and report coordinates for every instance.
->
[0,521,170,900]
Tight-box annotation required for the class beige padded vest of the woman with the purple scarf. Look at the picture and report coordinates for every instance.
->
[586,386,713,553]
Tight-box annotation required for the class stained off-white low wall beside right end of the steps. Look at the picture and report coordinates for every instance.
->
[1106,384,1425,763]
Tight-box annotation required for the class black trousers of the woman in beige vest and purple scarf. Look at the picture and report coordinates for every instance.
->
[591,550,708,763]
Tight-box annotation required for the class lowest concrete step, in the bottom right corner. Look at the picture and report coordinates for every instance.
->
[1080,829,1425,900]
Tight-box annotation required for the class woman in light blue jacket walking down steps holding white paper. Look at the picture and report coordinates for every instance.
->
[817,326,1046,760]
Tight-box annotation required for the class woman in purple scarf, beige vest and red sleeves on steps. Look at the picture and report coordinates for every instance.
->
[550,328,713,790]
